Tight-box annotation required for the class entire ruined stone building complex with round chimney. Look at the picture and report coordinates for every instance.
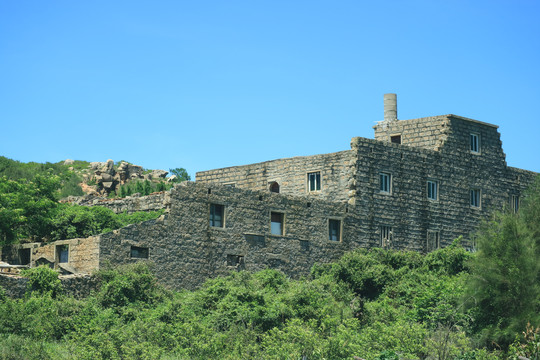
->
[2,94,536,288]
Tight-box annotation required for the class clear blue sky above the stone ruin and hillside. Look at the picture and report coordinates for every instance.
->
[0,0,540,177]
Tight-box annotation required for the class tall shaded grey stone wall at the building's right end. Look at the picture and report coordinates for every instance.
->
[352,129,537,251]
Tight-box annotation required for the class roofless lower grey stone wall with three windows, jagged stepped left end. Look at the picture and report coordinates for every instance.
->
[100,183,366,288]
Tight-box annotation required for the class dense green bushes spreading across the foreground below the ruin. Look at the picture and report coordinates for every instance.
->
[0,248,510,359]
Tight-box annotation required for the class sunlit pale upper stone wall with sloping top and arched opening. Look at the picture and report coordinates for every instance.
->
[196,150,354,201]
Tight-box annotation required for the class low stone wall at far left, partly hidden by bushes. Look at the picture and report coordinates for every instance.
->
[0,274,99,299]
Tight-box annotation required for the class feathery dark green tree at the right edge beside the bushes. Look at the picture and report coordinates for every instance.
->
[468,174,540,348]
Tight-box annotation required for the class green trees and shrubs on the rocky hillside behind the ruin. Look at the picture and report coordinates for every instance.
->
[0,156,189,246]
